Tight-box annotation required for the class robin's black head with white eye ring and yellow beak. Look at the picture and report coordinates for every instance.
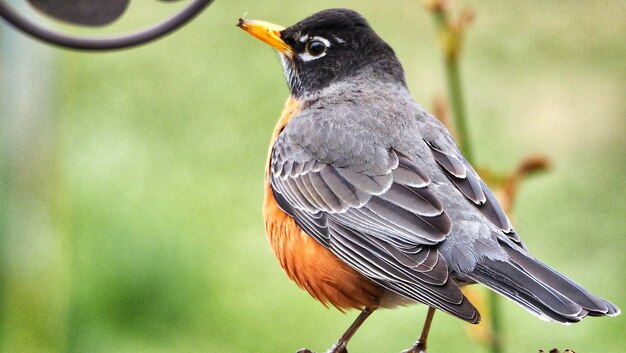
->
[237,9,404,97]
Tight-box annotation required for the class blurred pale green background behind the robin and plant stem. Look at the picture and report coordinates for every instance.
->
[0,0,626,353]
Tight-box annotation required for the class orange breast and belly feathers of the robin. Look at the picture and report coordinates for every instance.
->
[263,98,385,310]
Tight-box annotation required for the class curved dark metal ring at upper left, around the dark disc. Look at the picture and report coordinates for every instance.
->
[0,0,213,51]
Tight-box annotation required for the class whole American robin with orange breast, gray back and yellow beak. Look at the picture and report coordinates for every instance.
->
[238,9,620,353]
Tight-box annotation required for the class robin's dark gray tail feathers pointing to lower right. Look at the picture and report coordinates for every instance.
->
[466,244,620,323]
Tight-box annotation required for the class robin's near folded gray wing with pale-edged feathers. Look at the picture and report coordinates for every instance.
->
[270,117,479,323]
